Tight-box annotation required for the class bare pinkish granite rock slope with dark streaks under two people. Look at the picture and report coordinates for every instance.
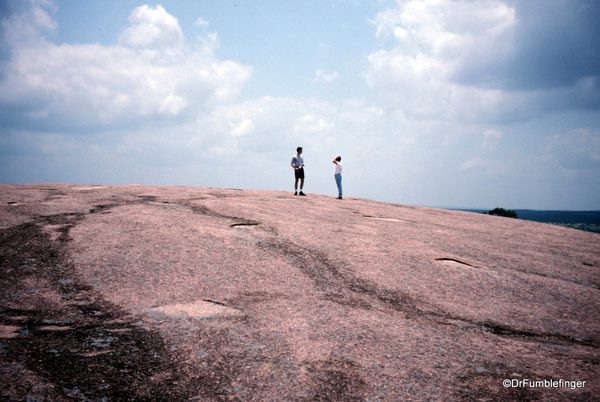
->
[0,184,600,401]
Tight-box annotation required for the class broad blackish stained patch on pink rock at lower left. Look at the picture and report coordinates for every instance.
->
[0,221,241,401]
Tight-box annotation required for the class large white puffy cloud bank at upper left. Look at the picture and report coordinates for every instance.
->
[0,4,252,128]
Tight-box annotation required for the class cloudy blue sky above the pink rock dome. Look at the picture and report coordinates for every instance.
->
[0,0,600,210]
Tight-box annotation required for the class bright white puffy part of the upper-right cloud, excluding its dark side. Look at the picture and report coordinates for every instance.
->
[365,0,516,120]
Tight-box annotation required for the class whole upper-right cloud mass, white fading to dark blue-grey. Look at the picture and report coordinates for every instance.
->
[365,0,600,122]
